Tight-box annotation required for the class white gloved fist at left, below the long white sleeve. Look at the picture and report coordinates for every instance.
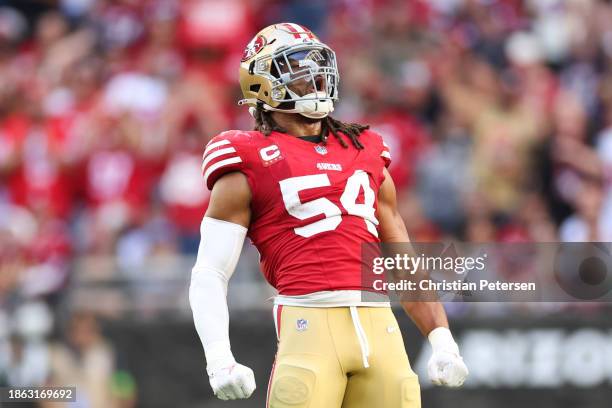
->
[206,357,255,400]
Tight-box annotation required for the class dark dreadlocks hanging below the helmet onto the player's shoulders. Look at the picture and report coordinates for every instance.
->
[253,105,370,149]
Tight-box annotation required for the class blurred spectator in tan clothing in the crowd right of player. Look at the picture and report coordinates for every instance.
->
[444,55,538,213]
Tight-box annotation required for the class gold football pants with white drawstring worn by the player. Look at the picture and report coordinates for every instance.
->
[266,306,421,408]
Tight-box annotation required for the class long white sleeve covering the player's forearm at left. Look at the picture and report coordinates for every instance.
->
[189,217,247,373]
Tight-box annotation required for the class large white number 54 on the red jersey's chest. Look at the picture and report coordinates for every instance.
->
[279,170,378,238]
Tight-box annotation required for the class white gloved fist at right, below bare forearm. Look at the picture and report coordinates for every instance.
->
[427,327,469,387]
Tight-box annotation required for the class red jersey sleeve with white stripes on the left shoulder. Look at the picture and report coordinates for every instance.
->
[202,131,247,190]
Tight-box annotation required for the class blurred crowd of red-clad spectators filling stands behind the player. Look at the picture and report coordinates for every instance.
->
[0,0,612,402]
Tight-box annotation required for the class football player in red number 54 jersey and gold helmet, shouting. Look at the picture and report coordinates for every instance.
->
[189,23,468,408]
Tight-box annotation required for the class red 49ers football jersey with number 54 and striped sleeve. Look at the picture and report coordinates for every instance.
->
[202,130,391,295]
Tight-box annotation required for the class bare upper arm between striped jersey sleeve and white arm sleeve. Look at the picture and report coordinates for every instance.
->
[206,171,251,228]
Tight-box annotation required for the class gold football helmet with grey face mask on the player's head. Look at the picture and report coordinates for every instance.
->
[238,23,340,119]
